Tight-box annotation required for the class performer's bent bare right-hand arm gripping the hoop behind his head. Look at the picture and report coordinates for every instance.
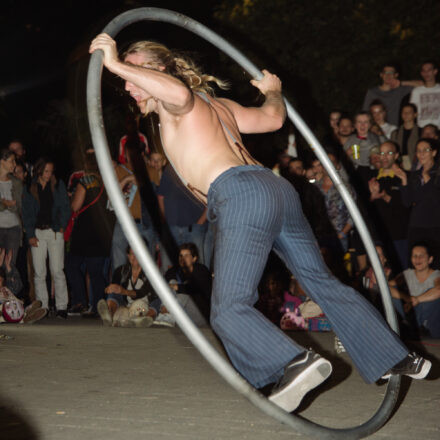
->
[219,70,286,133]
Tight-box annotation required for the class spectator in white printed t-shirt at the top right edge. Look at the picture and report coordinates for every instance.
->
[409,61,440,128]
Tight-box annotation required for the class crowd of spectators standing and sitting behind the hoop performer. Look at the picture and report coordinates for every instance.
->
[0,61,440,337]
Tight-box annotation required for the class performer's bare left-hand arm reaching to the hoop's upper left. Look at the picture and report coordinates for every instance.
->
[89,34,194,115]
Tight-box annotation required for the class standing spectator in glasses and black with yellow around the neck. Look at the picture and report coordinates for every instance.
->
[368,141,410,273]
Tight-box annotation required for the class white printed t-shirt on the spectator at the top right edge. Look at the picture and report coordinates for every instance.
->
[409,84,440,128]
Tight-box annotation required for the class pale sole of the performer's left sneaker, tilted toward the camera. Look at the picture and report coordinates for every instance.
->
[269,358,332,412]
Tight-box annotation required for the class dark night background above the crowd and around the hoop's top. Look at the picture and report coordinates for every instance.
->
[0,0,440,176]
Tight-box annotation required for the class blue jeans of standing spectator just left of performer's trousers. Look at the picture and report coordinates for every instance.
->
[160,223,208,273]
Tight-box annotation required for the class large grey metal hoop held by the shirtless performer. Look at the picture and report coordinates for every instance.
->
[87,8,400,439]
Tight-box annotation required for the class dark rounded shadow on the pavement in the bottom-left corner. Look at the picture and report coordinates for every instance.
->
[0,398,41,440]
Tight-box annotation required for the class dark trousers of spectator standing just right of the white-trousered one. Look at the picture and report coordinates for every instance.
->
[65,253,107,311]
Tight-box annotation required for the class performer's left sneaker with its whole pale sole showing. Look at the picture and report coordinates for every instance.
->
[269,350,332,412]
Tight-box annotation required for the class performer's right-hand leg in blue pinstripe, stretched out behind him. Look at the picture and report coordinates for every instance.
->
[274,179,408,382]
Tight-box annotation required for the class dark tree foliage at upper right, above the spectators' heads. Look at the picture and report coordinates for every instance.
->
[216,0,440,134]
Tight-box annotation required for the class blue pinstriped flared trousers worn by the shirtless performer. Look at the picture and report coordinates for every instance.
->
[208,165,408,388]
